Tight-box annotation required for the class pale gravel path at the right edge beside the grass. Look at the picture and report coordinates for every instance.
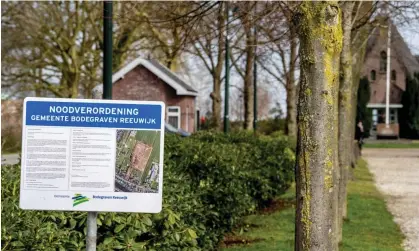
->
[363,149,419,251]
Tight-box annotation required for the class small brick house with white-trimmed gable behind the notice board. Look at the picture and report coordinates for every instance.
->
[93,58,198,133]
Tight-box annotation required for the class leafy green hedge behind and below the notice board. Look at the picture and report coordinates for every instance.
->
[1,132,294,251]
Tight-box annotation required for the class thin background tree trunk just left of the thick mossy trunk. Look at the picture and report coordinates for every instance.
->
[286,24,297,138]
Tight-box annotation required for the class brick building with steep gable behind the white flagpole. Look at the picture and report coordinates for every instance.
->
[362,20,419,137]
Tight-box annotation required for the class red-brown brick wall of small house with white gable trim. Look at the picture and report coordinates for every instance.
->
[112,66,195,132]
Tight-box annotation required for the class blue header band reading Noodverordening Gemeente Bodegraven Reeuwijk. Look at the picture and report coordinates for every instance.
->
[26,100,162,129]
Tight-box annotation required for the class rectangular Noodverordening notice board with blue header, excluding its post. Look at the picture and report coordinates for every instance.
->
[20,98,164,213]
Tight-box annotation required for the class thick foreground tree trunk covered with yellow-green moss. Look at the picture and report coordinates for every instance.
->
[295,2,342,251]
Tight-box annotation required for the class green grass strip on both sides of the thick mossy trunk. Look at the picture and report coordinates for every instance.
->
[222,160,403,251]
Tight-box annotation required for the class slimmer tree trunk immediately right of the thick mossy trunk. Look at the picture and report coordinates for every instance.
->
[337,2,355,242]
